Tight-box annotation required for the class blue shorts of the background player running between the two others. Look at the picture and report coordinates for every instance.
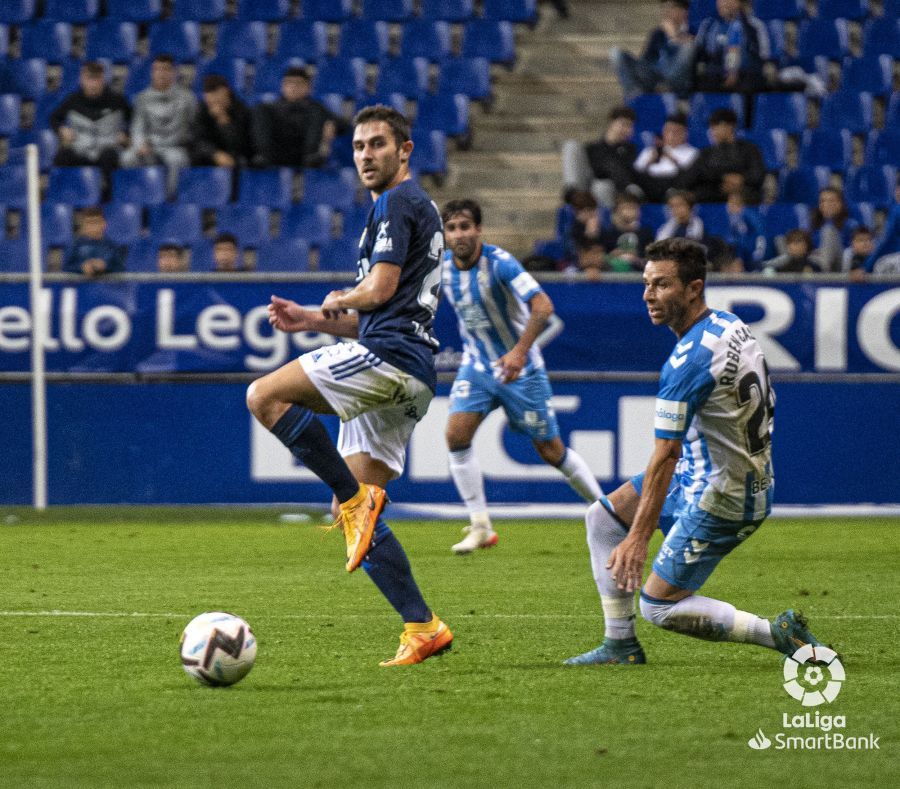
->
[450,365,559,441]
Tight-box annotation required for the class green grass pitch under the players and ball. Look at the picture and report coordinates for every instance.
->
[0,508,900,789]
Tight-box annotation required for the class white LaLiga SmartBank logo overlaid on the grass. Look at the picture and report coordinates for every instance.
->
[747,644,880,751]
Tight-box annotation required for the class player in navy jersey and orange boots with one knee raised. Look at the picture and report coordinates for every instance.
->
[247,105,453,666]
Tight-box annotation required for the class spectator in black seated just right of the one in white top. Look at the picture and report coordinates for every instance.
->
[682,107,766,205]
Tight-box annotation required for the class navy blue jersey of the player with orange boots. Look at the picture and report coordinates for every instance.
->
[356,180,444,390]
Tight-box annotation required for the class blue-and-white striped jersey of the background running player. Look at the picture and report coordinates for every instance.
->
[441,244,544,372]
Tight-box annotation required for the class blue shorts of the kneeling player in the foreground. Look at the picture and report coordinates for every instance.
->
[631,474,765,592]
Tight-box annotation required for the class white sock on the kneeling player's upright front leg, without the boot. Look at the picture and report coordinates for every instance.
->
[584,501,634,638]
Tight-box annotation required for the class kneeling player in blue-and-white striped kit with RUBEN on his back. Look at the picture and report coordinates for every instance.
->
[566,238,819,665]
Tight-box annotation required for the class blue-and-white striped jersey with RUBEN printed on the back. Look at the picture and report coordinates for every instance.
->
[654,310,775,522]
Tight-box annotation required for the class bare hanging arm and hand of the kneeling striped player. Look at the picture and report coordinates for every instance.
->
[606,438,681,592]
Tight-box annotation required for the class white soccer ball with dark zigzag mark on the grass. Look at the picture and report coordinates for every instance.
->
[181,611,256,687]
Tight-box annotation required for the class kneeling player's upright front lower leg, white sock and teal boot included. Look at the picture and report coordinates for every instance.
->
[565,497,647,666]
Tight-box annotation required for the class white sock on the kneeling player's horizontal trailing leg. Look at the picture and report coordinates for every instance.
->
[641,594,775,649]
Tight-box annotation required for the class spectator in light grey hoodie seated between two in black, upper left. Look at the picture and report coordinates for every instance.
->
[122,54,197,196]
